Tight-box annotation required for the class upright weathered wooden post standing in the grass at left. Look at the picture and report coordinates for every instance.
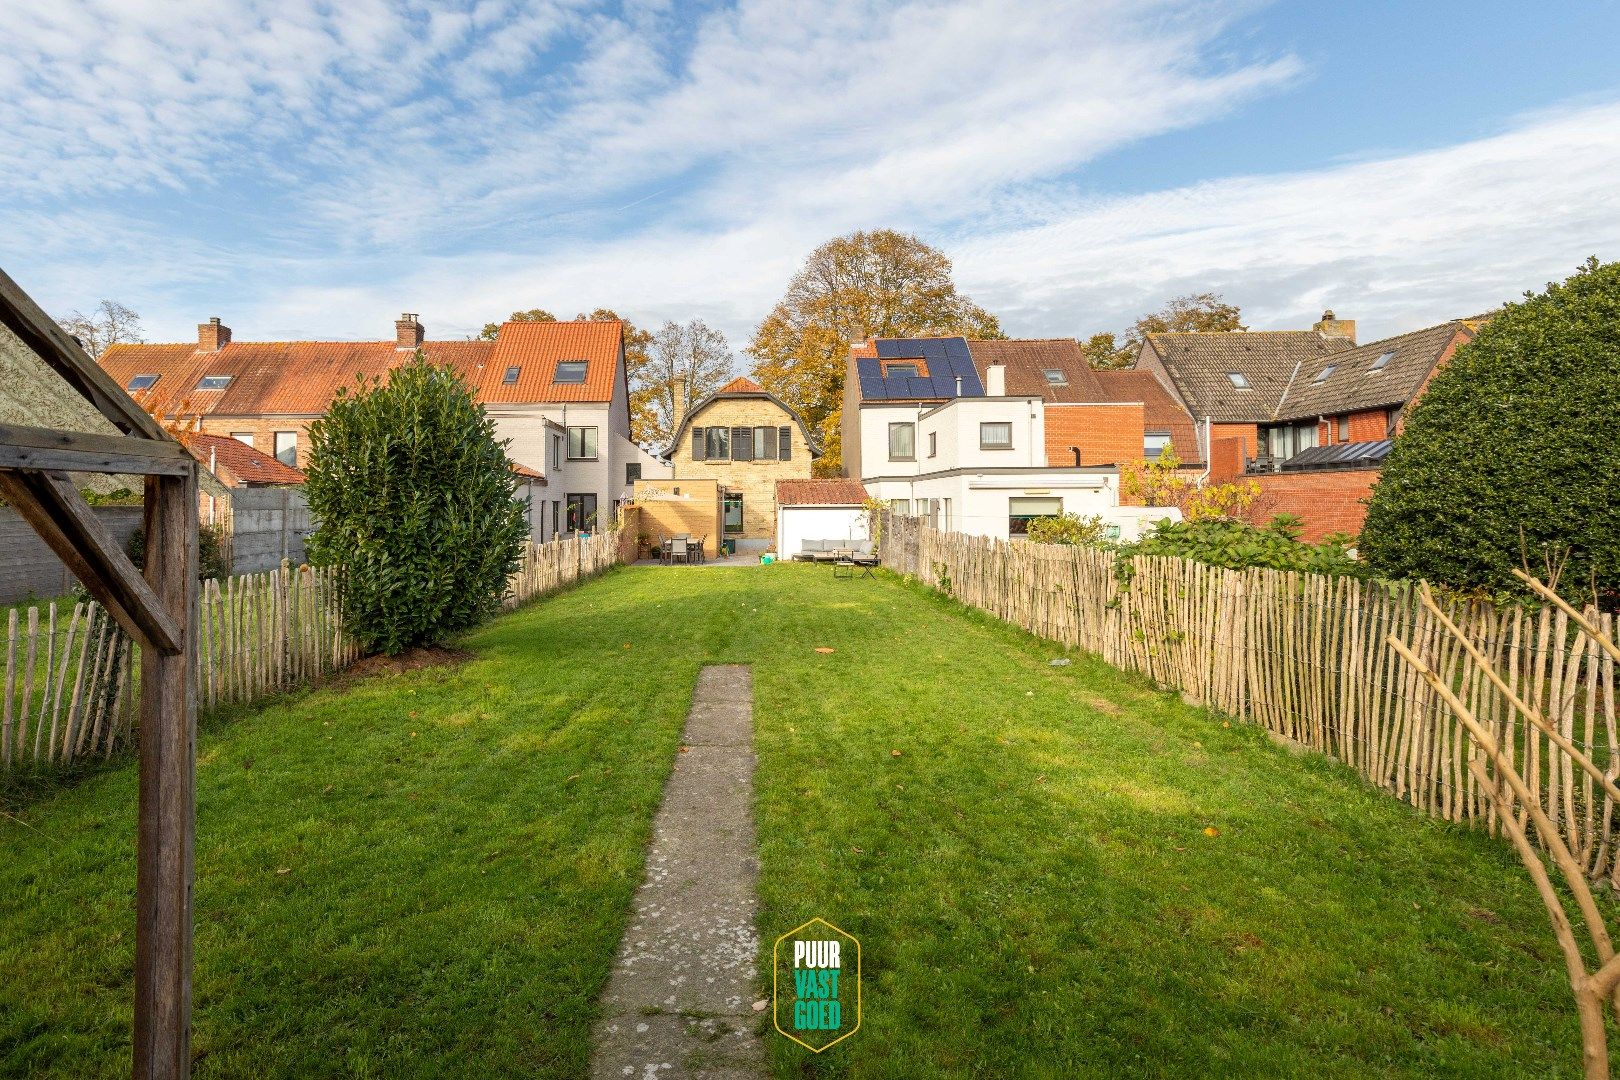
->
[134,473,198,1080]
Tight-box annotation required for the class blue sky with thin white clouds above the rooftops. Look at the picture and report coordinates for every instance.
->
[0,0,1620,350]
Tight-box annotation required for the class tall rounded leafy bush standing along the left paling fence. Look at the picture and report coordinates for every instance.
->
[305,359,527,656]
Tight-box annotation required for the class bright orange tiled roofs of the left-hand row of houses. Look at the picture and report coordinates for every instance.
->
[100,322,624,416]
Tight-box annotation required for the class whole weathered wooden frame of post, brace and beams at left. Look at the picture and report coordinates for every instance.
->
[0,263,198,1080]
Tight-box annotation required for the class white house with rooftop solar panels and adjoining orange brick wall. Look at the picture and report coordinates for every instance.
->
[844,338,1179,539]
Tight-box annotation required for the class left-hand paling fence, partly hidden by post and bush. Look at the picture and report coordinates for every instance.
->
[0,533,619,767]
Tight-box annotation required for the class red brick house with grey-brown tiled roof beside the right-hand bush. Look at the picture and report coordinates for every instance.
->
[1137,311,1479,541]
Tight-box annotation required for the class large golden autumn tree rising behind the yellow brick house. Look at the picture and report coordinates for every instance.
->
[747,228,1004,476]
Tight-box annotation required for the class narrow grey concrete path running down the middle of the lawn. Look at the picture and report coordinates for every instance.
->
[591,665,768,1080]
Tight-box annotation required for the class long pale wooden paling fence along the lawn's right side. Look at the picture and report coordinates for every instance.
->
[881,517,1620,886]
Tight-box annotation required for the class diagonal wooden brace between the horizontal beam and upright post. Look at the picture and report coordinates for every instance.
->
[0,463,182,654]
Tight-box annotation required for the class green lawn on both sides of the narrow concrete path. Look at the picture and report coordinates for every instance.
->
[0,565,1600,1077]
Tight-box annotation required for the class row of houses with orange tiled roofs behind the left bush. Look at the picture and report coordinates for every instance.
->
[100,314,640,539]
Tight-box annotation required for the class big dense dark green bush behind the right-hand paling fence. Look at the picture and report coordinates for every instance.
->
[1361,259,1620,607]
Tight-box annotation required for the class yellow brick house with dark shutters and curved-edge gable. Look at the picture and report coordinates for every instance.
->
[659,377,821,549]
